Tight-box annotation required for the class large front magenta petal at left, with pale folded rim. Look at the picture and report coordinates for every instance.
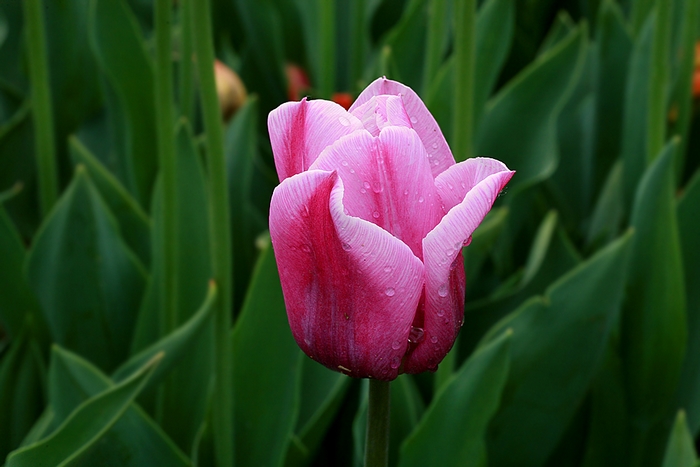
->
[270,170,423,380]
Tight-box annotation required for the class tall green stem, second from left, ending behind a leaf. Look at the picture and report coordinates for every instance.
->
[153,0,178,336]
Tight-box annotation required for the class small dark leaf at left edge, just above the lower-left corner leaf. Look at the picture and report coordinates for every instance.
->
[0,334,44,459]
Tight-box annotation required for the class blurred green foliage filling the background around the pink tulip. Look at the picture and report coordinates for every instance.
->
[0,0,700,467]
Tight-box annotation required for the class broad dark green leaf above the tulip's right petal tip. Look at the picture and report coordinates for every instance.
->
[476,25,587,192]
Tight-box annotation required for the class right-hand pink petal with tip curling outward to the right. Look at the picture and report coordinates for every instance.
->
[405,170,514,373]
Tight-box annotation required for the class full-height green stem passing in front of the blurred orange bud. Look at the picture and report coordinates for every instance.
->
[191,0,233,467]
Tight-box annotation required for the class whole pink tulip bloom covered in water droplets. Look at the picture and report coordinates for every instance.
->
[268,78,514,381]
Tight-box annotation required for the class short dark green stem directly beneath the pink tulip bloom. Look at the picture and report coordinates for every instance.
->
[365,379,391,467]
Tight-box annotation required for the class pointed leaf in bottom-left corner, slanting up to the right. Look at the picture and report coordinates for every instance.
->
[5,355,161,467]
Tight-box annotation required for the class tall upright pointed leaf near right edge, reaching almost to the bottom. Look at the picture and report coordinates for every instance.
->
[622,139,687,465]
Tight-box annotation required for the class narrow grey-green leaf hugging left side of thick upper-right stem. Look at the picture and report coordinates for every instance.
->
[621,15,654,206]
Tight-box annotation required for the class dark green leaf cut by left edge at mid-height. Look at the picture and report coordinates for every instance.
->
[0,204,40,340]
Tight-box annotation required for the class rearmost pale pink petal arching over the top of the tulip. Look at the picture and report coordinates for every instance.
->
[350,78,455,177]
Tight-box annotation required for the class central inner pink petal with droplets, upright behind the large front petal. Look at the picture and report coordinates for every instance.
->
[311,126,442,258]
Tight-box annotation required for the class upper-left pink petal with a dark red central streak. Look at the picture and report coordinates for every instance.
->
[267,98,362,181]
